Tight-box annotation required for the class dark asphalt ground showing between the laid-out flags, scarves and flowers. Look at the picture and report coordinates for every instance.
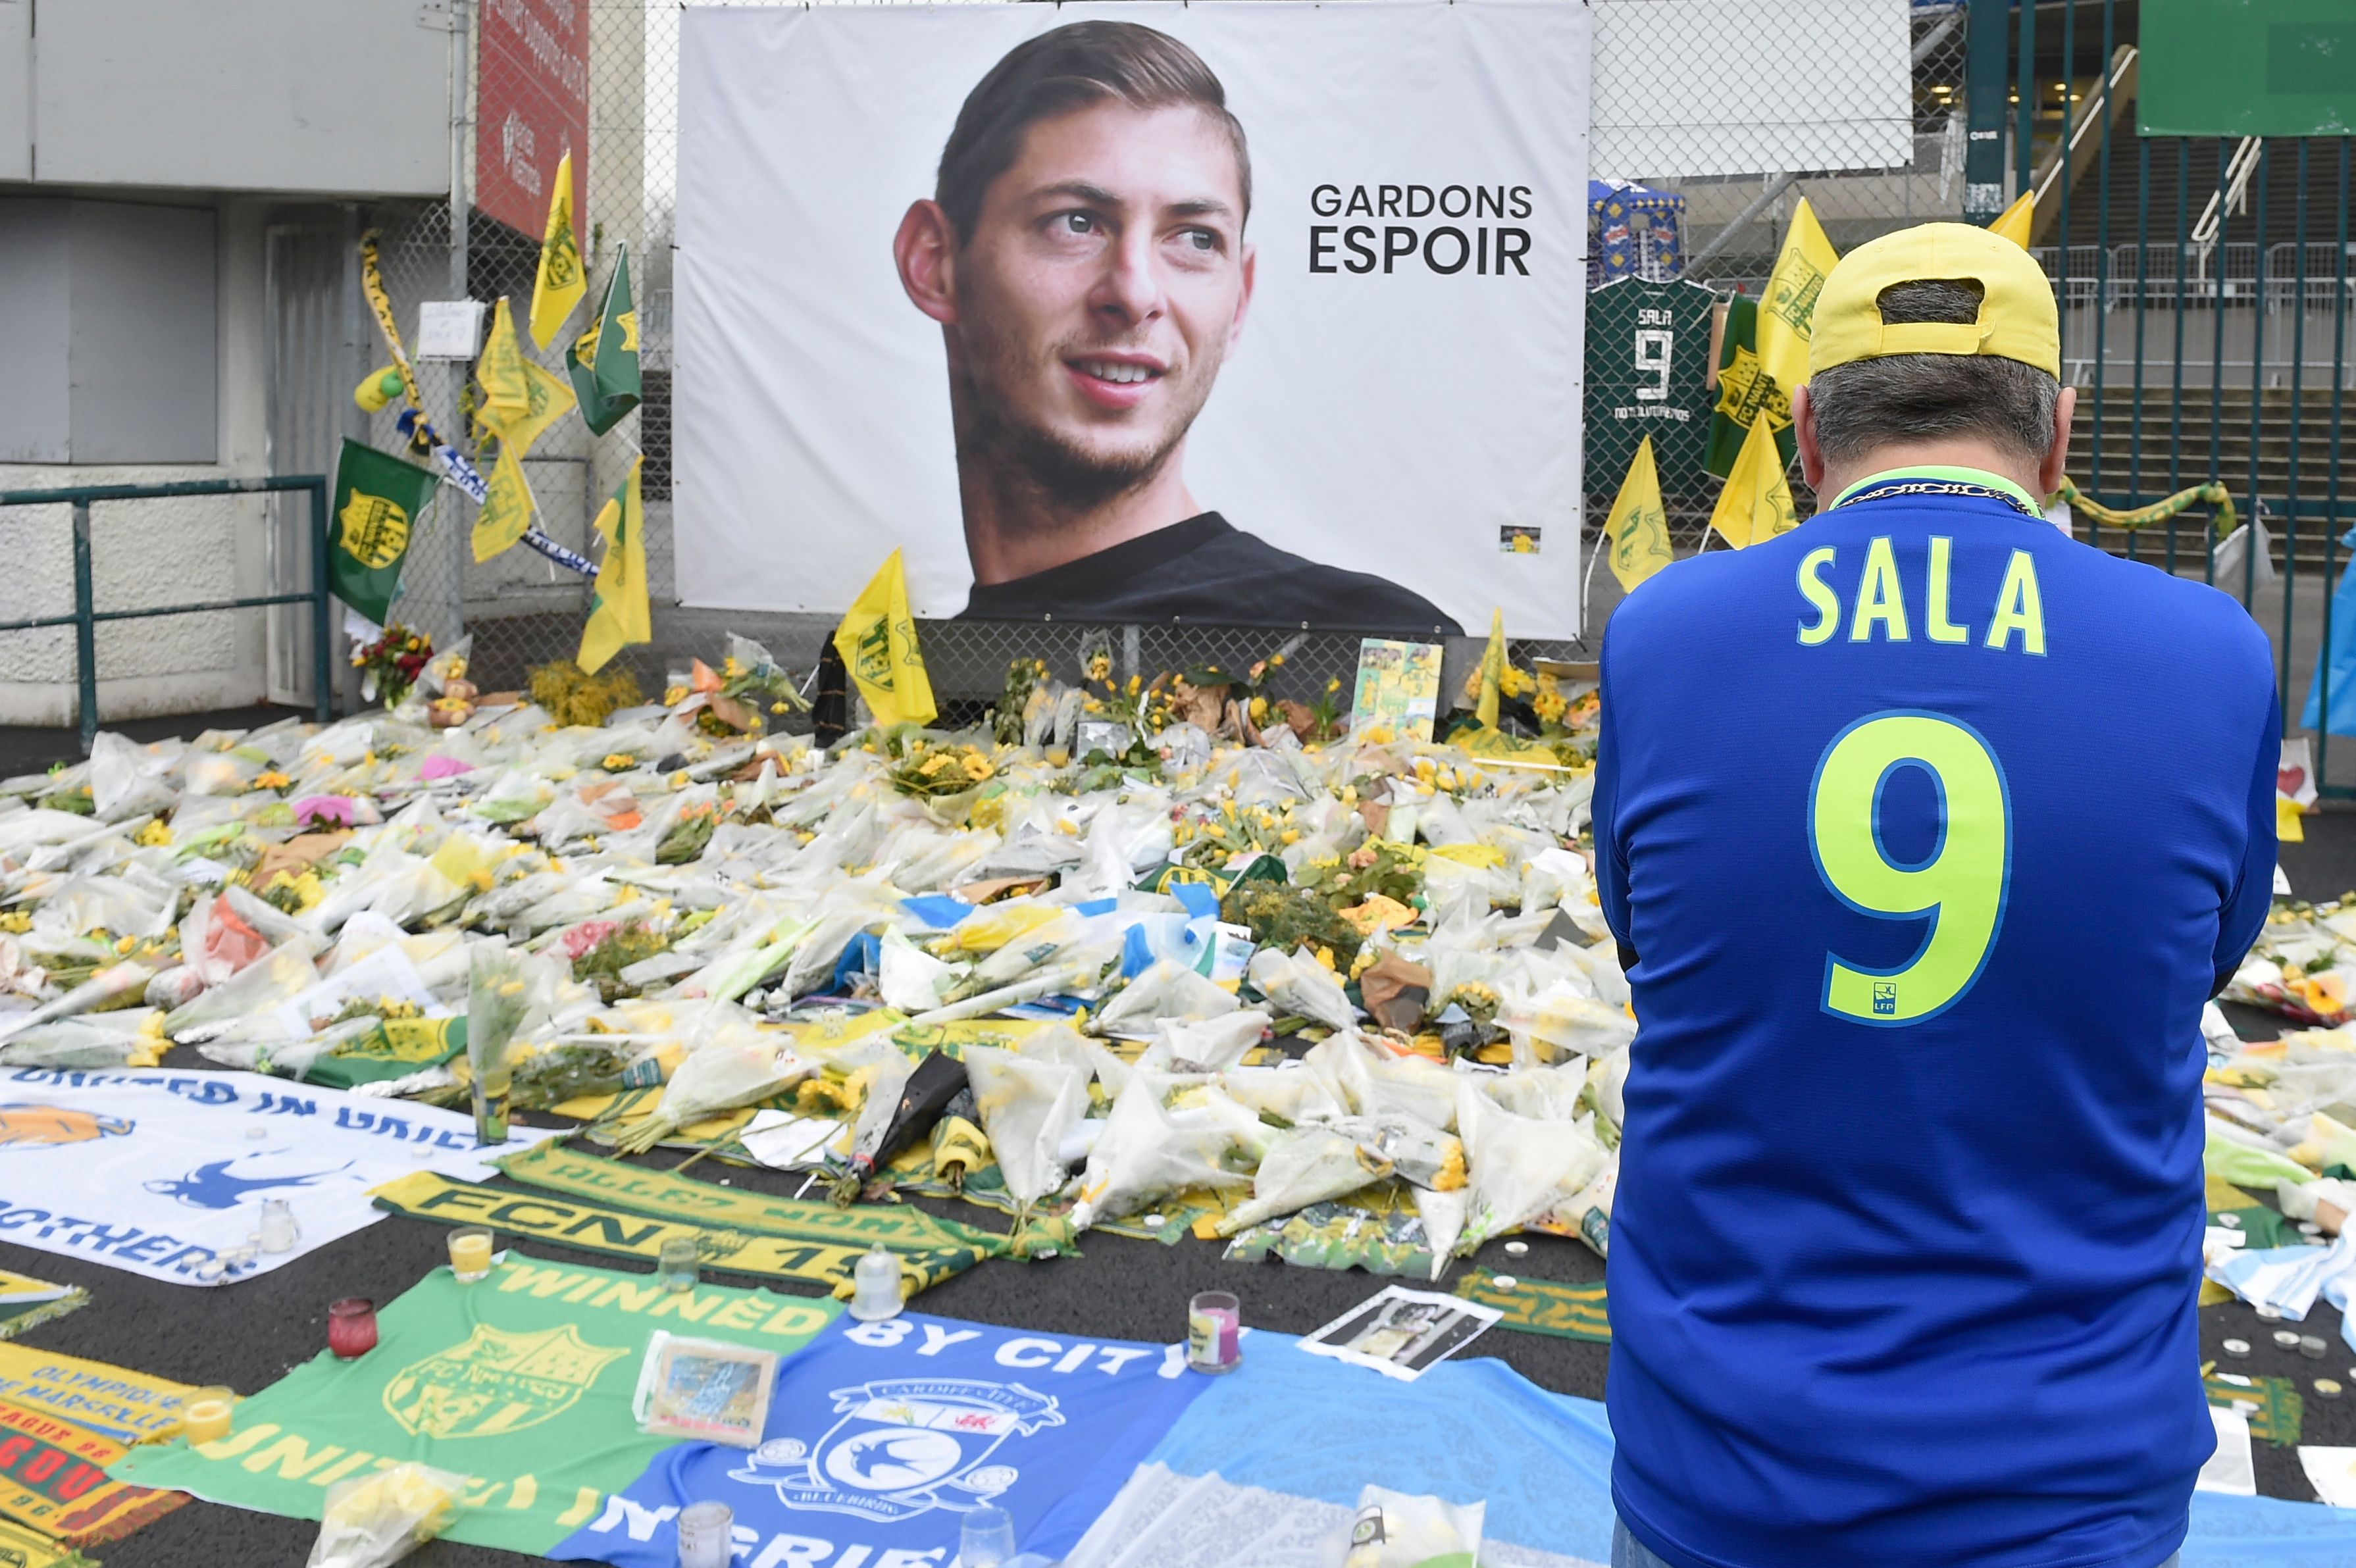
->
[0,716,2356,1568]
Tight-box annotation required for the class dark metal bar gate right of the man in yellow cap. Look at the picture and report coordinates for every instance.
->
[2010,0,2356,798]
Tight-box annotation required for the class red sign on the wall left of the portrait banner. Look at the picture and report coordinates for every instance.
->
[474,0,589,240]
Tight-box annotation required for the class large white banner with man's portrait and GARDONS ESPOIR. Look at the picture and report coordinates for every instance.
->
[674,0,1588,636]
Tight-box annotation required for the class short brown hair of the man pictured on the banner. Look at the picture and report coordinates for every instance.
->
[933,21,1251,240]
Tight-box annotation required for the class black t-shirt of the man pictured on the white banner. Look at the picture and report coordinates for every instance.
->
[956,511,1463,638]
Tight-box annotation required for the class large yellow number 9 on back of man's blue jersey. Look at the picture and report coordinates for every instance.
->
[1807,709,2012,1026]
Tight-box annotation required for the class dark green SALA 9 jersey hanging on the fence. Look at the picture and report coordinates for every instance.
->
[1585,278,1715,492]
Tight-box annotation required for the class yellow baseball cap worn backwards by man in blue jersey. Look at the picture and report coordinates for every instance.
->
[1807,224,2062,379]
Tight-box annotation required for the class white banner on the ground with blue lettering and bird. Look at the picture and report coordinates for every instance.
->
[0,1067,547,1286]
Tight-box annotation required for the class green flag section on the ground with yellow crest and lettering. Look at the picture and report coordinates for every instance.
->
[115,1252,841,1556]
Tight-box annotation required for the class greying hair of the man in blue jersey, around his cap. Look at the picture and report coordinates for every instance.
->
[1807,278,2062,464]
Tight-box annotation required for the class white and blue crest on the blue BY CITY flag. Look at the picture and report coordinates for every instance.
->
[728,1377,1063,1523]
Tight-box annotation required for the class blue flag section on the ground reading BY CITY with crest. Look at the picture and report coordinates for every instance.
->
[549,1311,1211,1568]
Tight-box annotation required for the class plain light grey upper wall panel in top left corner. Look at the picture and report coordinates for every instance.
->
[0,0,450,195]
